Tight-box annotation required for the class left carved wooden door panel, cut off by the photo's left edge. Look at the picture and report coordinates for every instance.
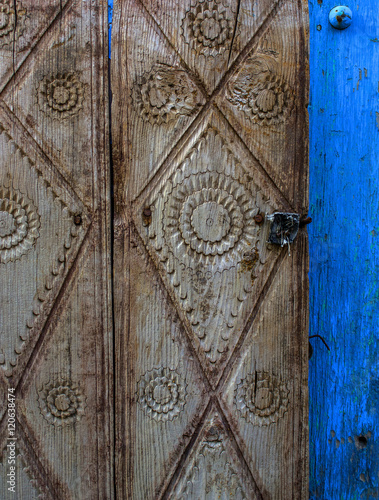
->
[0,0,113,500]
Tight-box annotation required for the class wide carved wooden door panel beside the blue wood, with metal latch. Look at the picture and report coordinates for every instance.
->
[112,0,308,500]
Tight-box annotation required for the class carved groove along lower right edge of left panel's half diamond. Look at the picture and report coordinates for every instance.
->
[9,221,94,394]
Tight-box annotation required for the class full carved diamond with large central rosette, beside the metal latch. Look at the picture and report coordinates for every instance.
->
[136,118,276,386]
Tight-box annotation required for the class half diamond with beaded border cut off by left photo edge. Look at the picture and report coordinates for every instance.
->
[0,121,88,378]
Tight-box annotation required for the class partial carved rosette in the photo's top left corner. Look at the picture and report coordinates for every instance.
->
[0,0,26,48]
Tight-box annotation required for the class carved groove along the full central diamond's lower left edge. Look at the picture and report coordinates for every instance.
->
[130,221,212,392]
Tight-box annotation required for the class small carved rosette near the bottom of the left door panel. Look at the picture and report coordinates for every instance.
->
[39,381,84,426]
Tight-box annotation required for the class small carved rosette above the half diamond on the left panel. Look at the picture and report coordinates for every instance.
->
[37,72,84,119]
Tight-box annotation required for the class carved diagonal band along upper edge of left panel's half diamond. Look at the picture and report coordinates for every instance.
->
[0,101,85,213]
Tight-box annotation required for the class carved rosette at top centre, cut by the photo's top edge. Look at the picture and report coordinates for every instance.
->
[181,0,235,57]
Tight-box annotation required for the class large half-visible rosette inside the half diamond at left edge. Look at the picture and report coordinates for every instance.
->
[0,187,40,263]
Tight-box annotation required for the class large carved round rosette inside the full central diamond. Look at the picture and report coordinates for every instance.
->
[163,173,256,258]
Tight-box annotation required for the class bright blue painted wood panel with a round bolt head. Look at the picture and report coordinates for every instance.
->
[309,0,379,500]
